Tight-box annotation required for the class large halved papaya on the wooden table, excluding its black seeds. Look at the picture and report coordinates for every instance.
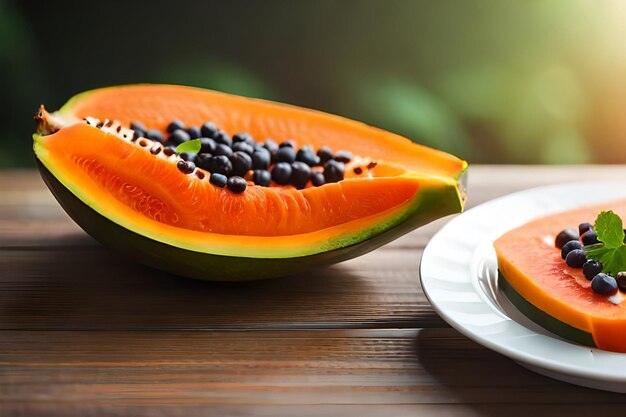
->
[34,85,467,280]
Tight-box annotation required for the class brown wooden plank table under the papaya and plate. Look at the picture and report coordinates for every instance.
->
[0,166,626,417]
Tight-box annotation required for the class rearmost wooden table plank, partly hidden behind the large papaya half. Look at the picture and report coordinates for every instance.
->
[0,165,626,248]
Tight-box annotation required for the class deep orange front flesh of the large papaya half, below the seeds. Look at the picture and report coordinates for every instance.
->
[43,122,420,236]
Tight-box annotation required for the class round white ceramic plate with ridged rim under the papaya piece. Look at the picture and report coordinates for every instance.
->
[420,182,626,392]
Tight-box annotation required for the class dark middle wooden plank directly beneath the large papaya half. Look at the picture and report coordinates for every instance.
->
[0,246,436,330]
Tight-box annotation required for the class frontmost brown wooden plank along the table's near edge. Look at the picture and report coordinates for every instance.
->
[0,329,626,415]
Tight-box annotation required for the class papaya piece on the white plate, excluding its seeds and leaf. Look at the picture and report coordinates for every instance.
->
[494,200,626,352]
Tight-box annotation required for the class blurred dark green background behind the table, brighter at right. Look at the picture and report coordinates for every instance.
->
[0,0,626,168]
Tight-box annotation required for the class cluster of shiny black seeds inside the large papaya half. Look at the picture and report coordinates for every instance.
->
[130,119,360,193]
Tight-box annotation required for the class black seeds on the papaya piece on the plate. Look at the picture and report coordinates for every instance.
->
[554,223,626,295]
